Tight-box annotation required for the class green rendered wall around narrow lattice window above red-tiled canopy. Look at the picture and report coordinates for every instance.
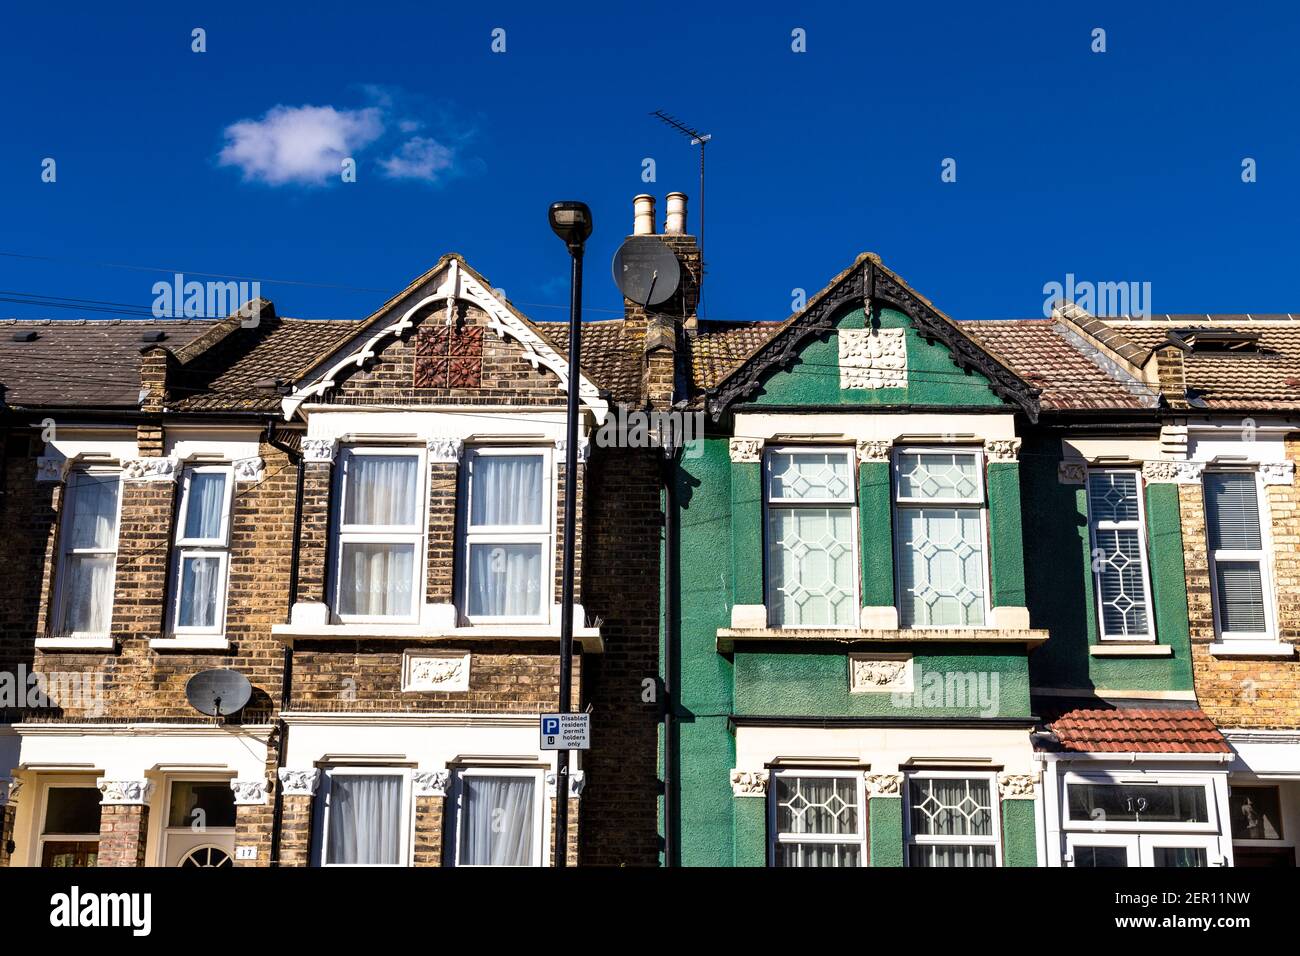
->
[1021,438,1192,692]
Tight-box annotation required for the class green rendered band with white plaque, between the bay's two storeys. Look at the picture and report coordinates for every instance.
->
[735,644,1030,718]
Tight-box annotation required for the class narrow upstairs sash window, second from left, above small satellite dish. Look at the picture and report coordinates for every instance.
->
[172,464,233,635]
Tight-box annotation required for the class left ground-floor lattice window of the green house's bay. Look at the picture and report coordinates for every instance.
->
[768,770,867,866]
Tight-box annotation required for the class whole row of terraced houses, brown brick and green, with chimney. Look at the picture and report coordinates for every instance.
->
[0,194,1300,866]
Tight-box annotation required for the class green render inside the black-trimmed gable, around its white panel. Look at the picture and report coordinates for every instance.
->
[746,307,1008,408]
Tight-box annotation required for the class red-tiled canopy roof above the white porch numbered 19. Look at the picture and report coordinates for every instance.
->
[1049,709,1231,753]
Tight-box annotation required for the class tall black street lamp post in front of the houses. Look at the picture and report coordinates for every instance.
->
[547,200,592,866]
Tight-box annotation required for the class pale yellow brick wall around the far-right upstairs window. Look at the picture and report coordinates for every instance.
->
[1178,438,1300,728]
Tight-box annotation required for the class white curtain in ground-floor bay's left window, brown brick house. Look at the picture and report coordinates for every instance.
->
[326,774,402,866]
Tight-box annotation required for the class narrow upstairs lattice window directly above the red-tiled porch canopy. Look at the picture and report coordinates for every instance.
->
[1088,468,1154,641]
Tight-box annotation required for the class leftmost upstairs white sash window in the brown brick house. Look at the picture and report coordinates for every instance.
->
[55,466,122,637]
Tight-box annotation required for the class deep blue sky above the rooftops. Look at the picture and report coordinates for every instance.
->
[0,0,1300,329]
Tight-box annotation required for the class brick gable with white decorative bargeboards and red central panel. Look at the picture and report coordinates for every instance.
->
[282,256,608,421]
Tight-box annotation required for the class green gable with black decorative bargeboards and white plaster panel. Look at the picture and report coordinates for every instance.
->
[706,254,1039,421]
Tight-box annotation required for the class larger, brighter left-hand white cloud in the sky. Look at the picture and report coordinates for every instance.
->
[218,105,379,186]
